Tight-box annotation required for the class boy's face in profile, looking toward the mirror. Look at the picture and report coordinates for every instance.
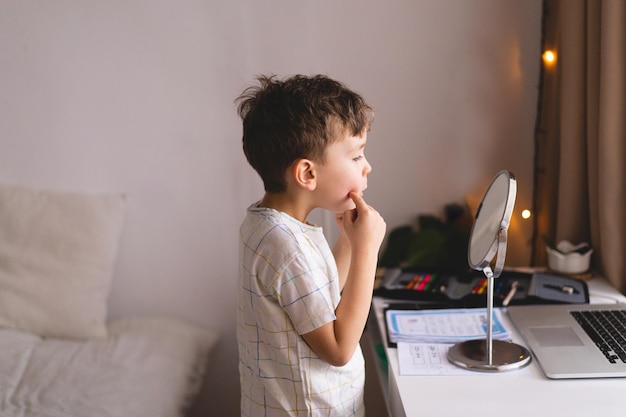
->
[316,133,372,213]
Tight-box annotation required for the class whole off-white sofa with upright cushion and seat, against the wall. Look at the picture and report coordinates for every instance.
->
[0,185,218,417]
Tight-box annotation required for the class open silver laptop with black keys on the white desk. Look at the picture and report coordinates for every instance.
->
[508,304,626,379]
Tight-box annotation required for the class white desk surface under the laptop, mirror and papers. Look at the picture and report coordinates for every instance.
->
[368,278,626,417]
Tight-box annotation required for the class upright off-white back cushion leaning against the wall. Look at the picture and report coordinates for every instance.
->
[0,185,126,339]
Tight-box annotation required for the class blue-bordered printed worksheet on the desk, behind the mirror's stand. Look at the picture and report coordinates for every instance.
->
[385,308,511,344]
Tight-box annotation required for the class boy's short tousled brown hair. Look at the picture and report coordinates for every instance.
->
[236,75,374,193]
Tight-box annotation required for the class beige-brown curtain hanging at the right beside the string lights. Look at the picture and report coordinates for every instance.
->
[531,0,626,293]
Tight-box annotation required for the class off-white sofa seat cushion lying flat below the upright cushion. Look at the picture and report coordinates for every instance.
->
[0,316,219,417]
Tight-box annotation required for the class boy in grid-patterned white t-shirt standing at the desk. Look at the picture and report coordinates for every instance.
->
[237,75,386,417]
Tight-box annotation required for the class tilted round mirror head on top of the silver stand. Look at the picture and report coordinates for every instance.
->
[467,171,517,278]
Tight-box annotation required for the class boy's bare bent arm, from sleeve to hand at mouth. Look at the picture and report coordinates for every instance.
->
[303,193,386,366]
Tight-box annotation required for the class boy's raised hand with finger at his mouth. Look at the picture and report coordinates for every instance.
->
[342,192,387,251]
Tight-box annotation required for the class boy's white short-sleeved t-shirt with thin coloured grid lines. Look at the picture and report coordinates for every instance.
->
[237,204,365,417]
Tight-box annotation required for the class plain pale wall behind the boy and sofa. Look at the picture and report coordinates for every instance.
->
[0,0,541,416]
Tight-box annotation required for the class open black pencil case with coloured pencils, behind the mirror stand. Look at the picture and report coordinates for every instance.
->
[374,268,589,308]
